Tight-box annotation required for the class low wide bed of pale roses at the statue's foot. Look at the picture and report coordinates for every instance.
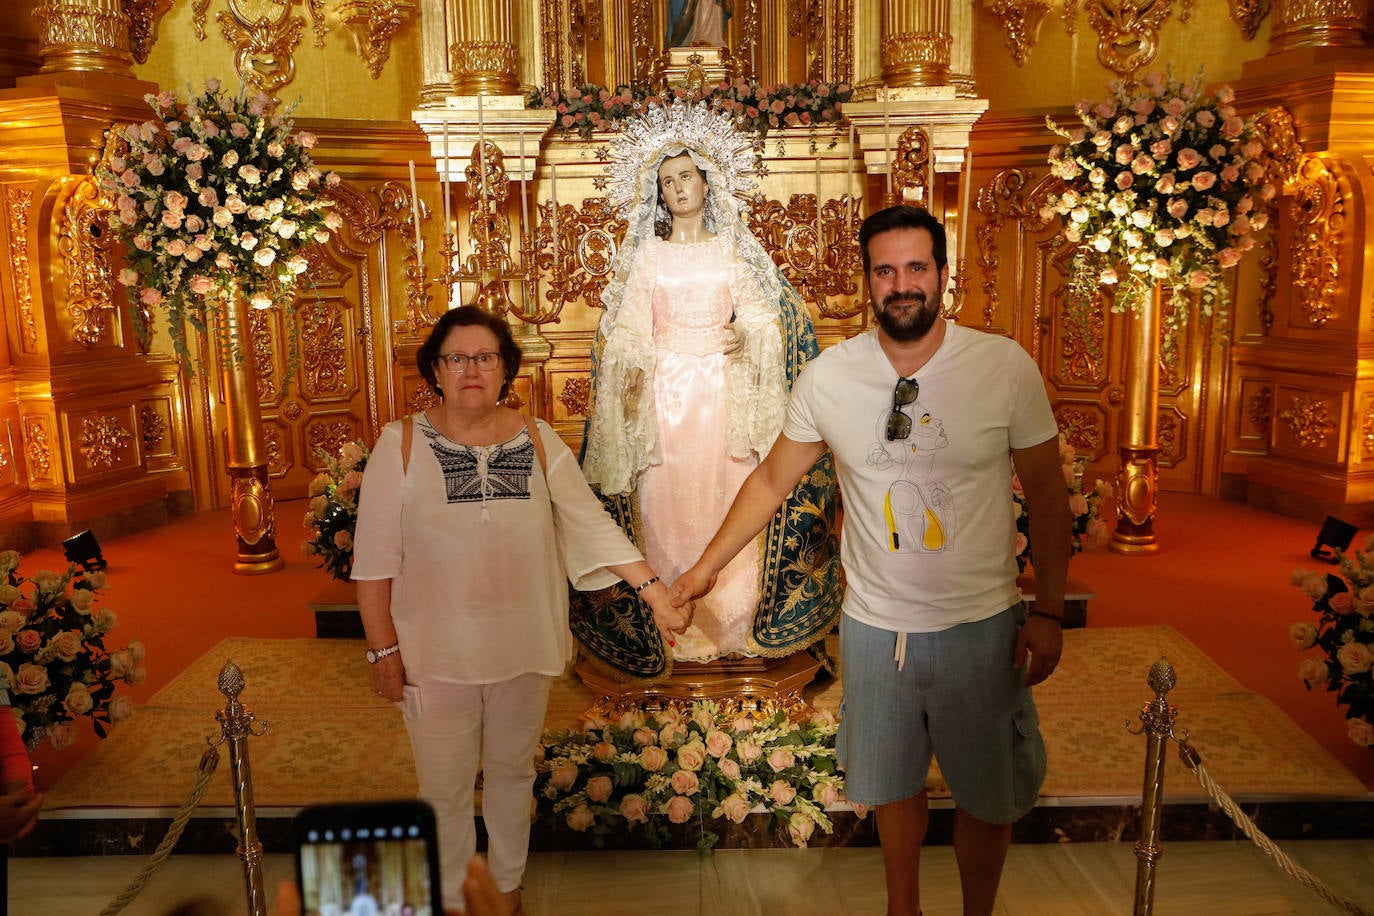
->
[534,700,844,850]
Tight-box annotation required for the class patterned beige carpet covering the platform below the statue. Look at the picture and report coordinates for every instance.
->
[45,626,1366,810]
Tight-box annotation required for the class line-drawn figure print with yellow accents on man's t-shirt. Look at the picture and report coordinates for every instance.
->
[868,398,956,553]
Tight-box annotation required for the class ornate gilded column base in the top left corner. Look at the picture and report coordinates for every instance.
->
[33,0,133,78]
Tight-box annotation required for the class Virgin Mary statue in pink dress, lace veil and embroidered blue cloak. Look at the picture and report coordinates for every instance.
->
[572,102,841,678]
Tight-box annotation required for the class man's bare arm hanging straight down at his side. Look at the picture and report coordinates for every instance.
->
[1011,438,1073,684]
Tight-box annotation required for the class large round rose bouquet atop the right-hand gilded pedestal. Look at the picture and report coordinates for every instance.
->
[1043,71,1276,351]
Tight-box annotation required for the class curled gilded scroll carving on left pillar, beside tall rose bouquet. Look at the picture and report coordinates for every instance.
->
[56,176,115,347]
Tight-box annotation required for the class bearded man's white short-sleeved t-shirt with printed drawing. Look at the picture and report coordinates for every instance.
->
[783,321,1058,633]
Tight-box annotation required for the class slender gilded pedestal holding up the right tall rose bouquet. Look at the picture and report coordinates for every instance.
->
[1107,284,1164,555]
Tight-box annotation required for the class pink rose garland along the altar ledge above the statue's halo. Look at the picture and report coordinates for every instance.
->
[528,80,853,139]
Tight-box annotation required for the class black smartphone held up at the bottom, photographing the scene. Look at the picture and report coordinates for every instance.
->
[293,799,444,916]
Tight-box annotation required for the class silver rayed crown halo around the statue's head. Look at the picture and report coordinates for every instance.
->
[607,99,763,220]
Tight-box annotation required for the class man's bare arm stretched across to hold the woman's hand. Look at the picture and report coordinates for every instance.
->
[673,435,818,607]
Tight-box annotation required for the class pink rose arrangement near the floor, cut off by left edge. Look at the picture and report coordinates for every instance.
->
[0,551,148,750]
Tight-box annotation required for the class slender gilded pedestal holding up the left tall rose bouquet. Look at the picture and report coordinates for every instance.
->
[220,294,286,575]
